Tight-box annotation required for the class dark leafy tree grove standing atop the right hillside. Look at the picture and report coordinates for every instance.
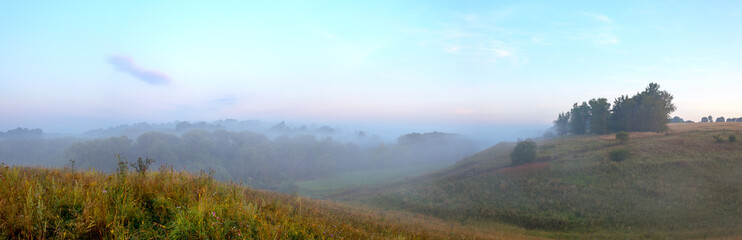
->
[554,83,675,136]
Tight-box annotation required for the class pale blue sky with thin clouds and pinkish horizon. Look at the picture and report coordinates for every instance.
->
[0,0,742,132]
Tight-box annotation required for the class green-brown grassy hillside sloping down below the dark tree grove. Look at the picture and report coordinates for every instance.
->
[335,123,742,239]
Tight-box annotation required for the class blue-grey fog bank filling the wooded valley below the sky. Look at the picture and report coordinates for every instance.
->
[0,119,545,192]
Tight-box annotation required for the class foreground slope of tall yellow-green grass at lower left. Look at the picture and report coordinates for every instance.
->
[0,164,548,239]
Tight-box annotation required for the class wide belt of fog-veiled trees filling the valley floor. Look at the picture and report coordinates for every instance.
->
[66,129,476,190]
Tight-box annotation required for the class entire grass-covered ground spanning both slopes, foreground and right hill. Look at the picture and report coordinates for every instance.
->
[0,123,742,239]
